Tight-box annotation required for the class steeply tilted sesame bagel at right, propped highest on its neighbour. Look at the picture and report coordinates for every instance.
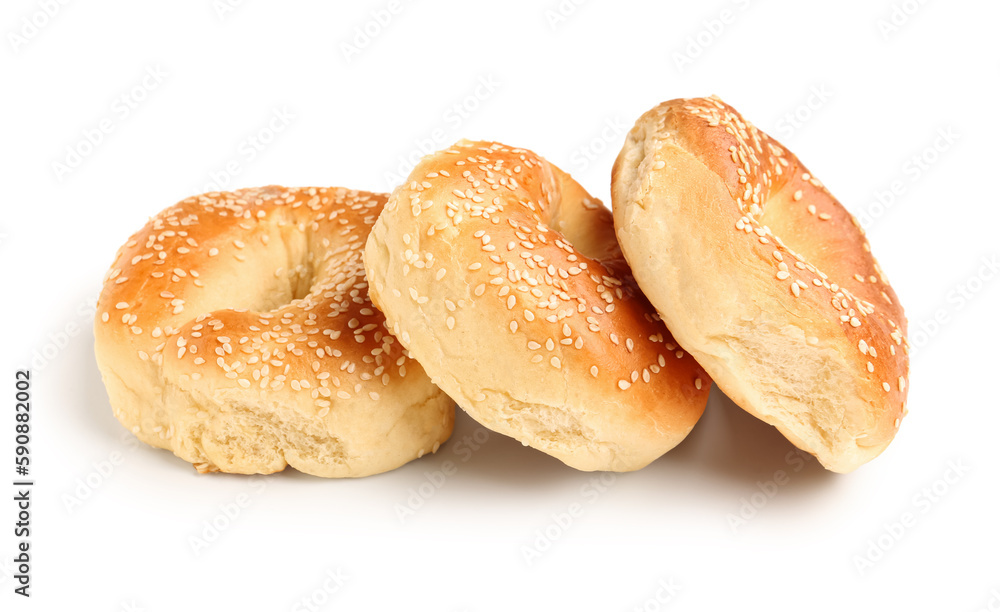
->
[612,98,909,472]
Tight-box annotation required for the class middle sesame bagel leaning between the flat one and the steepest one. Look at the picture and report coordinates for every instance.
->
[365,141,710,471]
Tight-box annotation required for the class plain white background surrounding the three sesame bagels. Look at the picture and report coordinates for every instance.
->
[0,0,1000,611]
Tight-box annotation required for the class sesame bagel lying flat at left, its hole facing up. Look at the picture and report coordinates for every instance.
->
[94,186,454,477]
